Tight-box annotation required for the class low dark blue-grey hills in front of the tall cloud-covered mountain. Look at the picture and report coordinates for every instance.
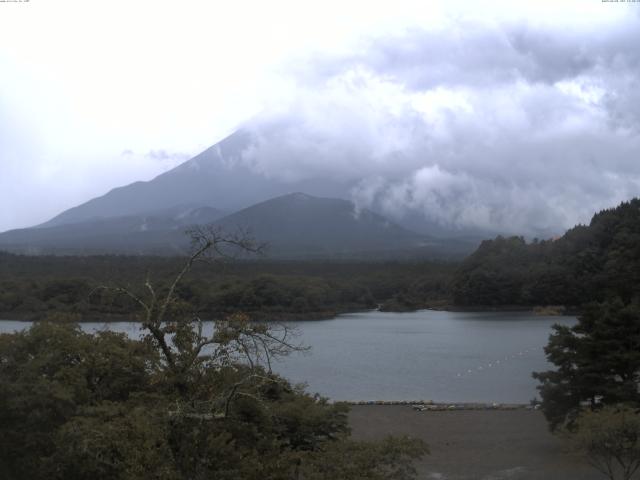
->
[0,193,473,259]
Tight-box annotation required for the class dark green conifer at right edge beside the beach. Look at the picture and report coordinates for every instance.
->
[534,299,640,429]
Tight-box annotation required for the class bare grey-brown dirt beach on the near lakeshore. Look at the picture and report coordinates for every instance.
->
[350,405,605,480]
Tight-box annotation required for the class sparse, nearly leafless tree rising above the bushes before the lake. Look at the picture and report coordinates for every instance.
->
[92,226,306,418]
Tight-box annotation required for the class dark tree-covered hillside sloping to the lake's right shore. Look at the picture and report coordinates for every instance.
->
[452,198,640,306]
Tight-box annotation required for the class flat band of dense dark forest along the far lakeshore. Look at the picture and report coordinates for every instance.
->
[0,253,456,321]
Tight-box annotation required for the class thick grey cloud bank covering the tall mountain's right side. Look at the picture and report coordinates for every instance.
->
[239,15,640,235]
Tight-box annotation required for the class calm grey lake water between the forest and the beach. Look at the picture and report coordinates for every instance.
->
[0,310,576,403]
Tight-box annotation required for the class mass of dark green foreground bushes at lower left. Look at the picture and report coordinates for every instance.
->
[0,318,426,480]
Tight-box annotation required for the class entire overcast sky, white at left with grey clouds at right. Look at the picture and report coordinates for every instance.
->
[0,0,640,231]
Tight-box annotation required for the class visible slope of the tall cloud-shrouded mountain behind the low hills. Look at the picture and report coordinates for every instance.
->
[30,129,495,243]
